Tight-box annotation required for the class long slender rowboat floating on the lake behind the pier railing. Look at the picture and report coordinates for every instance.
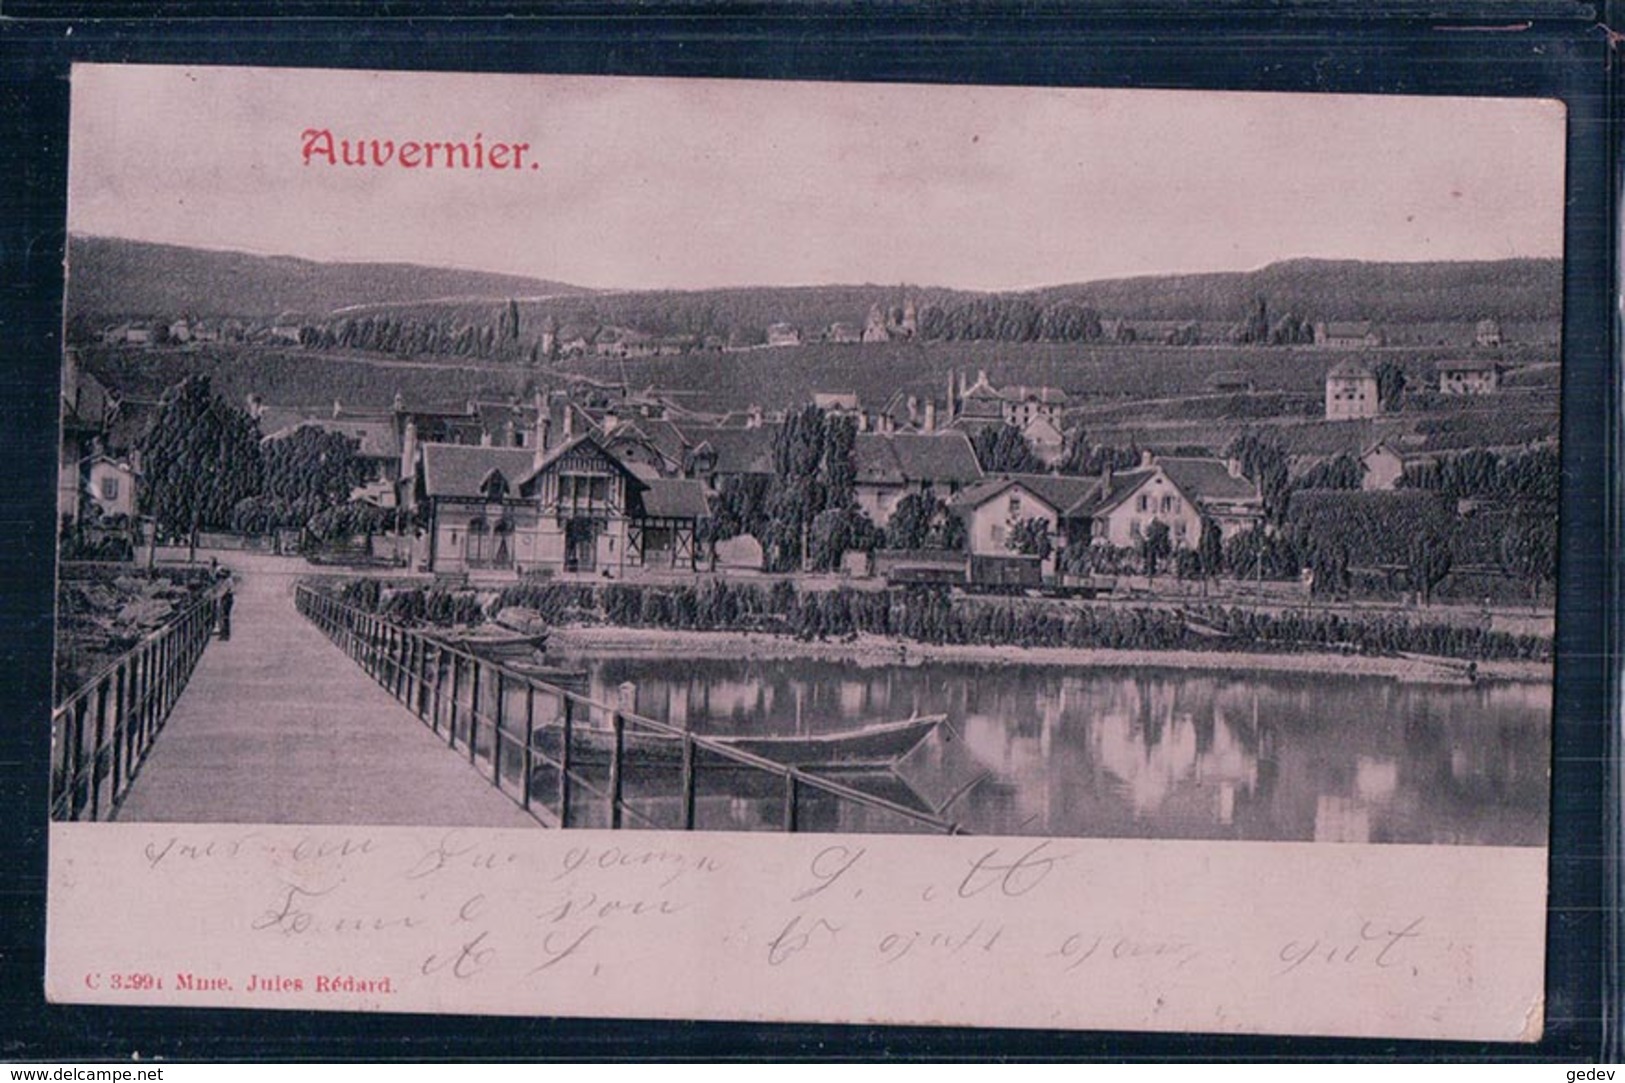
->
[533,714,947,771]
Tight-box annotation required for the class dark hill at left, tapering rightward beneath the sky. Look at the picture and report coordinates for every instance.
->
[68,236,585,320]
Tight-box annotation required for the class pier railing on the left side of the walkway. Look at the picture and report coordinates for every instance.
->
[50,587,219,820]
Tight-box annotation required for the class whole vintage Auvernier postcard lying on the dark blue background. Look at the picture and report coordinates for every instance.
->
[47,65,1565,1041]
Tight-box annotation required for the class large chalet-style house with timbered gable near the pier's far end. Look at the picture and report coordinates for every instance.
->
[414,433,709,576]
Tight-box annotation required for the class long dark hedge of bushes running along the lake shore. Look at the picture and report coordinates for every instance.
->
[330,579,1552,662]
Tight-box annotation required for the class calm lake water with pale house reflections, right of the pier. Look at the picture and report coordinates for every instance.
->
[583,657,1552,846]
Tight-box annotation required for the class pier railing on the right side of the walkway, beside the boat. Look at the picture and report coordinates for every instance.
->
[294,584,960,834]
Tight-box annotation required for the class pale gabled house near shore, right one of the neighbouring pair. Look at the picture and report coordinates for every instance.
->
[1090,452,1264,550]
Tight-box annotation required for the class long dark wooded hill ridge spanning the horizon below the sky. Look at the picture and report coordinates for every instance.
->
[68,236,1563,333]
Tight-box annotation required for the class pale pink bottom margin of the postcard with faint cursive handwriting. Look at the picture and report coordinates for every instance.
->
[41,824,1544,1037]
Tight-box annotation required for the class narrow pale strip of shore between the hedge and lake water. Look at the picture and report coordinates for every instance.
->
[548,626,1552,685]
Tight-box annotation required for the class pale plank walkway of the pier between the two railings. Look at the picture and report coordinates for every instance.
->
[115,553,540,828]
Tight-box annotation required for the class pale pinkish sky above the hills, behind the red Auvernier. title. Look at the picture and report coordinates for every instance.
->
[68,65,1565,289]
